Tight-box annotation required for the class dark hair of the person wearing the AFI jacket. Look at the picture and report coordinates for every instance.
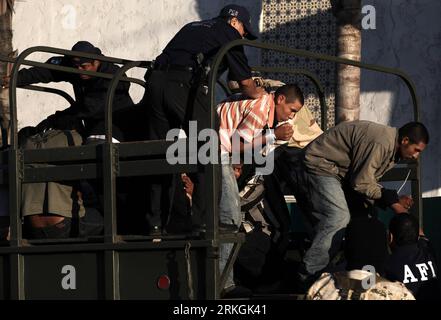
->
[389,213,420,247]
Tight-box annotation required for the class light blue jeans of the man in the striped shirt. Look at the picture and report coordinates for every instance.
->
[219,164,242,288]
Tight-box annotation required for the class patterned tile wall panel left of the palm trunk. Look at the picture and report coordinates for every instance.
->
[261,0,336,126]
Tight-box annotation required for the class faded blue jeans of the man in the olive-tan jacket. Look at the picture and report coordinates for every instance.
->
[303,173,350,275]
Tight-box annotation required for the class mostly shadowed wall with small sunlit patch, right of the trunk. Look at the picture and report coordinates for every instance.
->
[361,0,441,197]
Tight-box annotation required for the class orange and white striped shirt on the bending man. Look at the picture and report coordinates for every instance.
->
[217,93,275,154]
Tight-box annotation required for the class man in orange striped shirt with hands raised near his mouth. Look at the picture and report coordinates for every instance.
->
[217,84,304,294]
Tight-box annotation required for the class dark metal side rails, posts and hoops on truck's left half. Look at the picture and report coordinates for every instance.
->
[0,47,235,299]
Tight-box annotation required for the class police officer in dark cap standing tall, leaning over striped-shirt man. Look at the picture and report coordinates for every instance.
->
[146,5,264,234]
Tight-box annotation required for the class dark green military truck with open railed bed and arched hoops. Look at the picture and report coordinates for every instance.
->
[0,40,422,300]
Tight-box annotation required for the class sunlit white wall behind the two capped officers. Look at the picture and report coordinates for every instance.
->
[13,0,261,128]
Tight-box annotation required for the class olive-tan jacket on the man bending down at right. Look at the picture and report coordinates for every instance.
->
[304,121,398,200]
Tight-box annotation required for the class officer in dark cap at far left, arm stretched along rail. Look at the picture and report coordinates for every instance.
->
[3,41,133,141]
